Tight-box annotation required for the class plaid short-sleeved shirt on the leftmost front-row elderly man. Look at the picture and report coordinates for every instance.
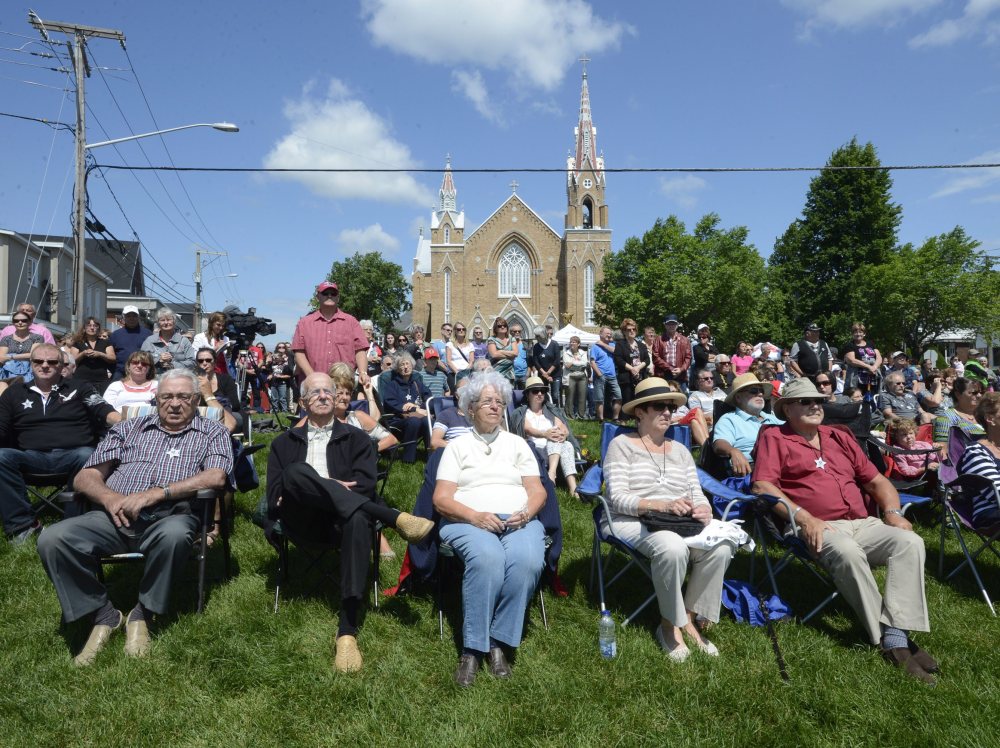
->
[84,415,233,495]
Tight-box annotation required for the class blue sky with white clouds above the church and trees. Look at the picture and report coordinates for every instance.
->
[0,0,1000,340]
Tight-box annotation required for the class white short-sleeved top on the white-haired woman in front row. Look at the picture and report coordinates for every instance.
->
[437,431,539,514]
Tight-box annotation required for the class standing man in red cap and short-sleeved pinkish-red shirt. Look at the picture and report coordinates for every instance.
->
[292,281,368,386]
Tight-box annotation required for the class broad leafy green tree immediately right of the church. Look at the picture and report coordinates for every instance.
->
[595,213,774,351]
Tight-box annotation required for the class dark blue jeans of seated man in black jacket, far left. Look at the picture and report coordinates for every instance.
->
[0,447,94,535]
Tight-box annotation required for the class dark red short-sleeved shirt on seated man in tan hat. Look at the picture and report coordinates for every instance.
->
[753,424,878,521]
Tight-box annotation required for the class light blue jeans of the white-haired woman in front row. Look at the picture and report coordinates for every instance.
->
[439,515,545,652]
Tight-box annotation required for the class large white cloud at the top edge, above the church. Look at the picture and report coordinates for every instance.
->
[361,0,634,121]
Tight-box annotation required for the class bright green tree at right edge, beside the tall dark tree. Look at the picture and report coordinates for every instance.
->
[853,226,1000,356]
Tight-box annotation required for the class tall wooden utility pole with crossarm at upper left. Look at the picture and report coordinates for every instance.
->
[28,10,125,330]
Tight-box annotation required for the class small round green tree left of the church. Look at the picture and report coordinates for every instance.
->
[312,252,411,330]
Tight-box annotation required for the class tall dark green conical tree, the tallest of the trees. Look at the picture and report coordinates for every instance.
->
[769,138,902,340]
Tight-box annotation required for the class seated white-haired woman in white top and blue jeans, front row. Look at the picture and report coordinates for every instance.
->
[434,372,546,687]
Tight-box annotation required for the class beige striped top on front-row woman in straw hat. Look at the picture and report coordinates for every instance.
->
[604,434,708,517]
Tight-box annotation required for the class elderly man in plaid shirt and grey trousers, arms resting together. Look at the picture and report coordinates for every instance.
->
[38,369,233,665]
